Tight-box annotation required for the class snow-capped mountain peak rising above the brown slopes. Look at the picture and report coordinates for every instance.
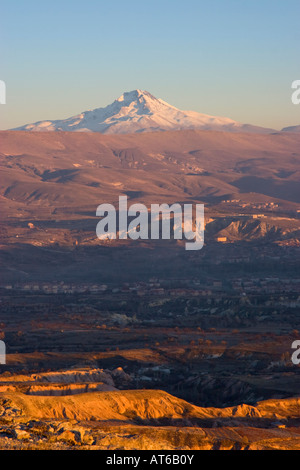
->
[14,90,273,134]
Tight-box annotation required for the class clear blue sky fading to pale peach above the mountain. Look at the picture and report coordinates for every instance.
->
[0,0,300,129]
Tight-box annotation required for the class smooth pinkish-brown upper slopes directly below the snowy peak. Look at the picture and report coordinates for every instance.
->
[0,131,300,216]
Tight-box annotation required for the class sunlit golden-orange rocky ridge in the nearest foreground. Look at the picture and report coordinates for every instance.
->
[0,382,300,450]
